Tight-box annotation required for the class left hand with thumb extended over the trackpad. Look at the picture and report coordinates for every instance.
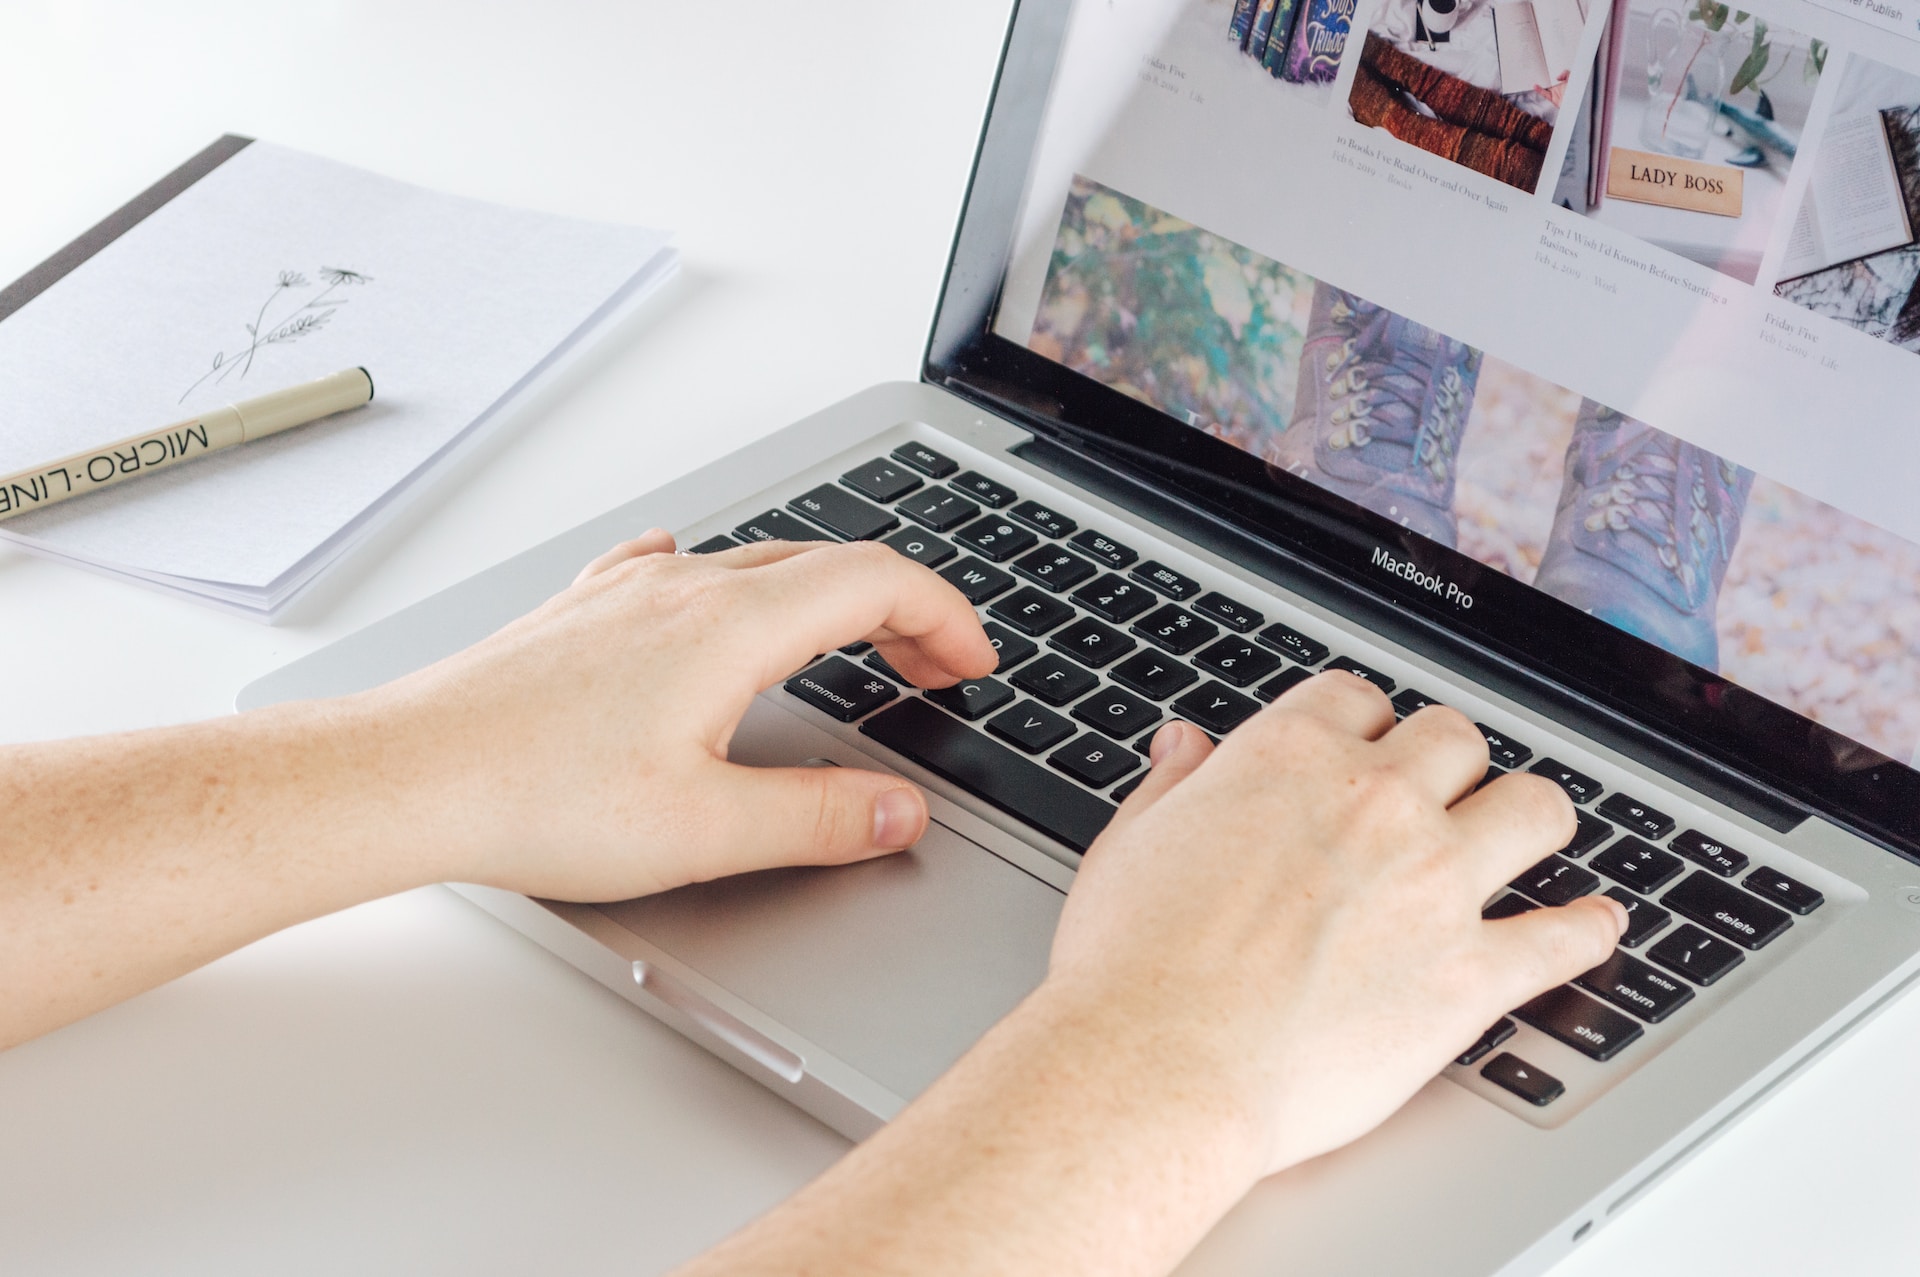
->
[357,530,996,901]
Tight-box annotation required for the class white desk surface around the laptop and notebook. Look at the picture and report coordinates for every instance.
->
[0,0,1920,1277]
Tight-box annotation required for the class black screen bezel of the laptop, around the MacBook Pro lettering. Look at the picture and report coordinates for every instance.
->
[922,0,1920,860]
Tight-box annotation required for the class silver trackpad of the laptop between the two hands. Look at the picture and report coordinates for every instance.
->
[601,822,1066,1098]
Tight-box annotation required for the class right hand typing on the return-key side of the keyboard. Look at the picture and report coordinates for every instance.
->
[1044,672,1626,1177]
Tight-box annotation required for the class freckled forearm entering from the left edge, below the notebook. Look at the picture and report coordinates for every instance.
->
[0,701,451,1048]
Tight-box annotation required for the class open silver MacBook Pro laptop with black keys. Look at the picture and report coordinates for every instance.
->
[240,0,1920,1277]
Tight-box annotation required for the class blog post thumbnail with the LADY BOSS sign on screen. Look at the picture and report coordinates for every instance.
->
[1553,0,1826,284]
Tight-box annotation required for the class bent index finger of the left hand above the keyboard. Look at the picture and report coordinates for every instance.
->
[732,542,1000,687]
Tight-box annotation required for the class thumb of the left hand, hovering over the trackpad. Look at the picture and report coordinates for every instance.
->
[689,762,927,879]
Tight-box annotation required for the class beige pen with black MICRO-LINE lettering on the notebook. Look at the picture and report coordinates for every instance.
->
[0,369,372,518]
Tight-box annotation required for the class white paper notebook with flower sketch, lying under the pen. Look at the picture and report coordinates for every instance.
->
[0,142,678,618]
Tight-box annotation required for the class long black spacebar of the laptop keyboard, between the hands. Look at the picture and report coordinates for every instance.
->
[860,697,1114,851]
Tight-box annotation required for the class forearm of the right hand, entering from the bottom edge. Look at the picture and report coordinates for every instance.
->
[678,989,1263,1277]
